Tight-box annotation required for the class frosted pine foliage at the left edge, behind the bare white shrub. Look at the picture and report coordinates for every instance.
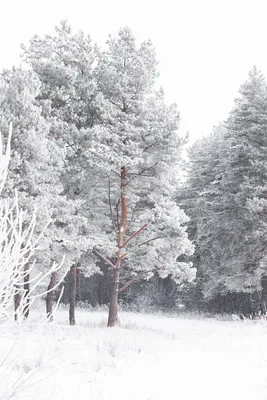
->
[0,68,87,318]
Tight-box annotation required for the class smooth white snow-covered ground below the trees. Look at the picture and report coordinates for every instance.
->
[0,309,267,400]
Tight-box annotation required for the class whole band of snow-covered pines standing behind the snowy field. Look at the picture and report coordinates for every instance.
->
[0,21,267,326]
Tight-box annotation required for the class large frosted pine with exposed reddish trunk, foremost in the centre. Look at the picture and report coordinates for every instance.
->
[86,27,195,326]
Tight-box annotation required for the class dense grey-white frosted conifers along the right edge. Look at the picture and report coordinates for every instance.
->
[185,67,267,311]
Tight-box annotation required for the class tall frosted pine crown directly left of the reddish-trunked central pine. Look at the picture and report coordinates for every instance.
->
[23,21,98,274]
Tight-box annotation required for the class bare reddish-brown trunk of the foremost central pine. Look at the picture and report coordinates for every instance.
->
[108,167,127,327]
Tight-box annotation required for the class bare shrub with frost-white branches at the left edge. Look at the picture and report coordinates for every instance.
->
[0,125,62,322]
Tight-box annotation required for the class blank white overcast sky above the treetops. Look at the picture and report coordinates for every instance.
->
[0,0,267,140]
